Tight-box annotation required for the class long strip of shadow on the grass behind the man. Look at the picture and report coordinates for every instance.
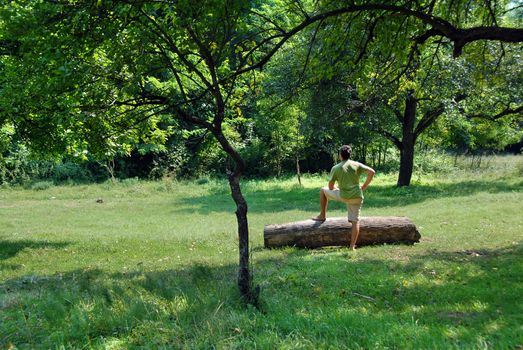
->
[175,180,523,214]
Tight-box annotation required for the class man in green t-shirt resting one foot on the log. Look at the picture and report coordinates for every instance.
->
[312,145,376,250]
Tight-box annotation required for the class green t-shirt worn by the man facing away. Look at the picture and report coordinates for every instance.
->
[330,160,370,199]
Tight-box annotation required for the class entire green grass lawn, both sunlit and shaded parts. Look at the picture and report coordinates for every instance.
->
[0,157,523,349]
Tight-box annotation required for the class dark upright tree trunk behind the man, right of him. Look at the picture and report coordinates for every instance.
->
[398,90,418,186]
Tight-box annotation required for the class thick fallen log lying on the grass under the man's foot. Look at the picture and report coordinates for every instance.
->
[263,216,421,248]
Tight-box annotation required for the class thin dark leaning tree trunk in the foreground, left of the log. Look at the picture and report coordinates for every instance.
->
[212,126,258,305]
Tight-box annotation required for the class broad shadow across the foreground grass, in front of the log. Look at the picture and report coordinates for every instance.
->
[0,243,523,348]
